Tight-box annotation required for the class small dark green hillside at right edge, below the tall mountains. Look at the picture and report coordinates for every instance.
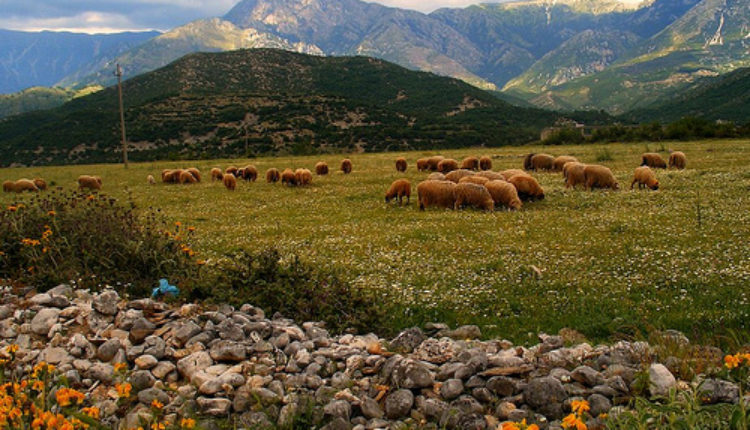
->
[624,68,750,124]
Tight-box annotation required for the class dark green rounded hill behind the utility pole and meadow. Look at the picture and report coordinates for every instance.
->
[0,49,558,166]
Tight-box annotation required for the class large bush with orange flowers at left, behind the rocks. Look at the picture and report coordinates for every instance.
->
[0,191,198,296]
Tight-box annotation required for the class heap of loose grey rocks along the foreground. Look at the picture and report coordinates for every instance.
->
[0,285,739,429]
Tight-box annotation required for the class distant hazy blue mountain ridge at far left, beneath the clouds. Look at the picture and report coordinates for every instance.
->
[0,30,159,94]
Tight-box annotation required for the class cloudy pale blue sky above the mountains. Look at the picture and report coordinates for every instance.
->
[0,0,506,33]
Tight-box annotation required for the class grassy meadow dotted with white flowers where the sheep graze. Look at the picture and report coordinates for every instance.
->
[0,140,750,343]
